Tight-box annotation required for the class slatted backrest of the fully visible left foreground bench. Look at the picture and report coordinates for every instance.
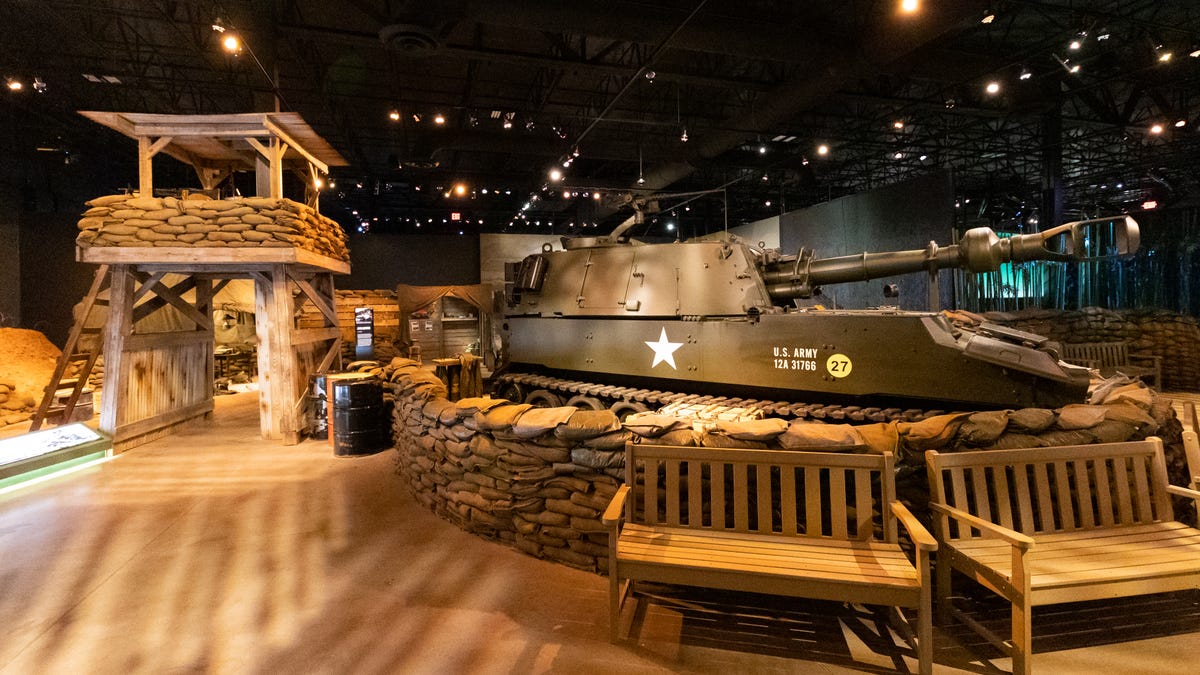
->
[625,443,896,542]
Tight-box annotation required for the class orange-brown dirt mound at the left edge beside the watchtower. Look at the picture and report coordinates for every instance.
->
[0,328,60,426]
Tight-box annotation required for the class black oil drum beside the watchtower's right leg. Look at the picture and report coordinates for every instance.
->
[332,377,391,456]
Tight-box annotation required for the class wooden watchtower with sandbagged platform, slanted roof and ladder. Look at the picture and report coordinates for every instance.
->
[34,112,350,452]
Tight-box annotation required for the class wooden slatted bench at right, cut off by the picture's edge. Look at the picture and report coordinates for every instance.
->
[925,437,1200,673]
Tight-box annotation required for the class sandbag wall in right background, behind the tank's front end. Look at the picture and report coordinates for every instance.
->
[947,307,1200,392]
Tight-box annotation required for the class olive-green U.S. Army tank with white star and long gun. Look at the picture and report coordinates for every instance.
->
[493,216,1139,420]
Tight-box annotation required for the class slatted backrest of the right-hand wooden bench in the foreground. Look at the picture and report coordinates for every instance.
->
[925,436,1174,539]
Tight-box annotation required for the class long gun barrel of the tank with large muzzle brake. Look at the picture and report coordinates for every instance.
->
[763,216,1139,301]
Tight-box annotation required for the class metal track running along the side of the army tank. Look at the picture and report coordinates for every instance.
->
[492,372,946,424]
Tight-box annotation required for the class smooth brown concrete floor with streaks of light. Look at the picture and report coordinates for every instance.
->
[0,393,1200,674]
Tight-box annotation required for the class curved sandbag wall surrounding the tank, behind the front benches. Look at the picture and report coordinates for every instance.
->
[379,358,1194,573]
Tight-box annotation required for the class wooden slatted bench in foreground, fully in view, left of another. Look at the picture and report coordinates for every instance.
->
[604,443,936,673]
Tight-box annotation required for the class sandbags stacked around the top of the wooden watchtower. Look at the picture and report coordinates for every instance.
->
[76,195,350,262]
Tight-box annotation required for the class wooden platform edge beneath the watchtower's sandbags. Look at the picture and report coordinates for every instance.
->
[76,246,350,274]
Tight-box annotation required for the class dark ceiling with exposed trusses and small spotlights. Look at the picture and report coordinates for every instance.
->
[0,0,1200,234]
